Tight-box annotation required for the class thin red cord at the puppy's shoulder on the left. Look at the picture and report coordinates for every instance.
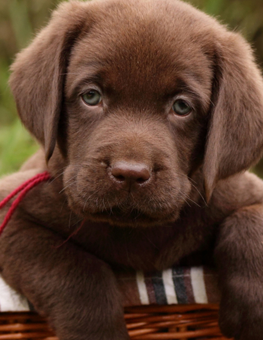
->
[0,171,51,235]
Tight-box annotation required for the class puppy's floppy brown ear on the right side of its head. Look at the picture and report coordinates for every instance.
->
[203,33,263,200]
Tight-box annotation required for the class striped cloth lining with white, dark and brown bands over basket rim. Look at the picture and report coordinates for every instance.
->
[0,267,220,312]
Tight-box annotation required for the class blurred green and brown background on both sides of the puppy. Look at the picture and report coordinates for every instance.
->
[0,0,263,177]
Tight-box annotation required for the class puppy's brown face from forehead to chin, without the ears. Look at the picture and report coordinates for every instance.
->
[64,5,213,225]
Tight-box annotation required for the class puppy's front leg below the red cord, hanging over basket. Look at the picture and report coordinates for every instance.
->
[0,216,129,340]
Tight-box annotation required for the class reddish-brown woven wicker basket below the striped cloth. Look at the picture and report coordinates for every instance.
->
[0,304,231,340]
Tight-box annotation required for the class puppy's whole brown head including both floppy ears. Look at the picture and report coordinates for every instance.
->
[10,0,263,225]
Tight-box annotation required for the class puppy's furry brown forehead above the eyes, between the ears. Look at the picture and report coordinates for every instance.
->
[68,0,217,99]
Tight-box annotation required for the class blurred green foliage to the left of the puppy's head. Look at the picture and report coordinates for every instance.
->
[0,0,61,176]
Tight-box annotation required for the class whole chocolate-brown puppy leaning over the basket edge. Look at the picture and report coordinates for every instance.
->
[0,0,263,340]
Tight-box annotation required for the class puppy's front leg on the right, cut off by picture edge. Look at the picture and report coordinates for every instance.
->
[215,204,263,340]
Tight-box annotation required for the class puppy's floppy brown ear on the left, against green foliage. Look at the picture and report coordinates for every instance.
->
[10,1,85,160]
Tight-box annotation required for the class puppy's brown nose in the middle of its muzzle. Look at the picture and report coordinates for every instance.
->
[111,161,151,186]
